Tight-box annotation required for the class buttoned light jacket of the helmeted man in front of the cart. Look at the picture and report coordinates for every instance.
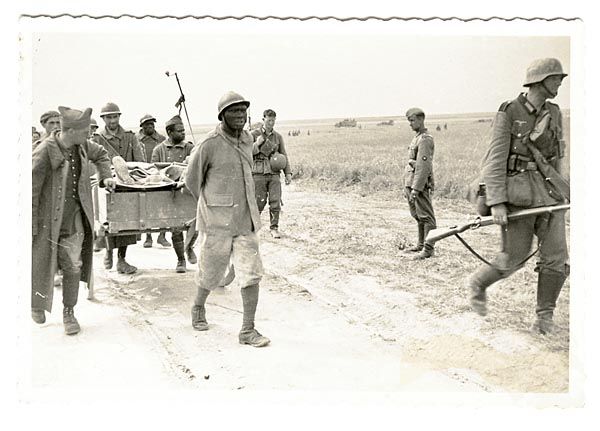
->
[185,123,261,236]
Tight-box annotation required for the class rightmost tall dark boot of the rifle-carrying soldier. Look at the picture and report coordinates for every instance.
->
[533,270,567,335]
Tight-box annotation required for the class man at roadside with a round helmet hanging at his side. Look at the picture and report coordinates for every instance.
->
[252,109,292,238]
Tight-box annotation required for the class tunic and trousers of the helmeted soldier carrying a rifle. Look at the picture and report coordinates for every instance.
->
[476,94,568,280]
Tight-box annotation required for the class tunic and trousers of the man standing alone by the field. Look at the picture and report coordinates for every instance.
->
[404,129,436,230]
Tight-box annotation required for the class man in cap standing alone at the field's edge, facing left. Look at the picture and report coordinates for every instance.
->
[404,108,436,260]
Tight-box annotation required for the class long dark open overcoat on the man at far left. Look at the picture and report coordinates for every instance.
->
[31,133,112,312]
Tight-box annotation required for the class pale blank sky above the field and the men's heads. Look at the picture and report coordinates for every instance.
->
[32,33,570,129]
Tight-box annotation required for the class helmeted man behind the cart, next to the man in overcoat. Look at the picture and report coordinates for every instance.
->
[95,102,146,274]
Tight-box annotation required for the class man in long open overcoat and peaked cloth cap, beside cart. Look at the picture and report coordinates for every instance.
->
[31,106,115,335]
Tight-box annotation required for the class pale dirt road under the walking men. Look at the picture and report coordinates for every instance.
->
[25,185,568,393]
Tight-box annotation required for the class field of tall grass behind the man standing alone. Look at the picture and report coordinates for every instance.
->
[276,114,569,199]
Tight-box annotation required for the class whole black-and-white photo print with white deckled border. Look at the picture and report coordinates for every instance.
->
[19,11,590,416]
